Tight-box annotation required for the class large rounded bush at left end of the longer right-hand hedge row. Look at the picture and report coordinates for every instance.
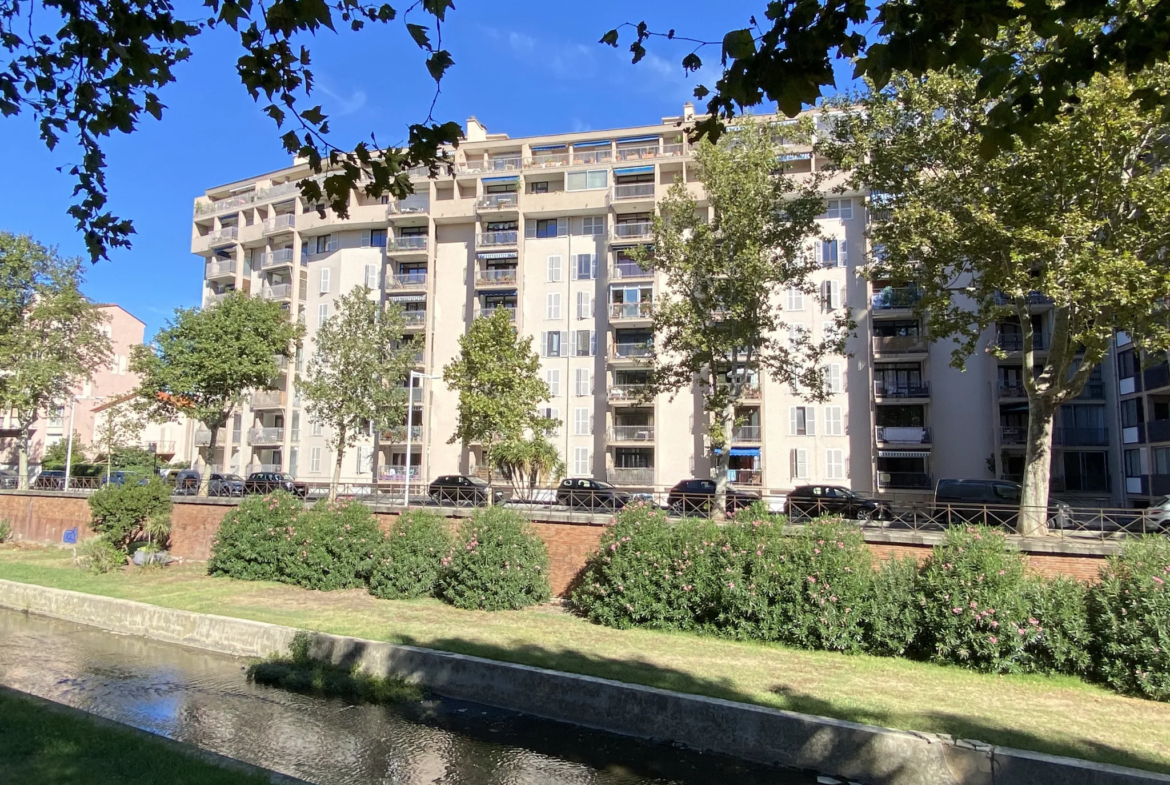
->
[570,504,723,629]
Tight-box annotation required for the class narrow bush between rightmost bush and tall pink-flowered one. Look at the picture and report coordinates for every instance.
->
[1024,576,1092,676]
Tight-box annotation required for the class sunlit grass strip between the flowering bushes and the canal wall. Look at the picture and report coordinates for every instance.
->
[0,546,1170,773]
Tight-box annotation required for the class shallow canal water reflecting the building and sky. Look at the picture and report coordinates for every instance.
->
[0,611,815,785]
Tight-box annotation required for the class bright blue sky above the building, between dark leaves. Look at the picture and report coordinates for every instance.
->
[0,0,847,337]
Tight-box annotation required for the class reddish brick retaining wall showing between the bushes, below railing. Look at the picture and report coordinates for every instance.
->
[0,490,1119,595]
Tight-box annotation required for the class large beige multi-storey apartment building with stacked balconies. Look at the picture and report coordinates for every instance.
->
[192,104,1119,507]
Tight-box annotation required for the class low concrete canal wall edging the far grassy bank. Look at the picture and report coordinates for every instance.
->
[0,580,1170,785]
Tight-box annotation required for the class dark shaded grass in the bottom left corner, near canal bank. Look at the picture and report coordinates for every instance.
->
[0,688,269,785]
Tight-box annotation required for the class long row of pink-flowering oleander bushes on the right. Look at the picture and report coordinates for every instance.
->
[571,505,1170,701]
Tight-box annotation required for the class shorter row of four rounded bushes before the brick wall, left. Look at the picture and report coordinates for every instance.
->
[208,491,551,611]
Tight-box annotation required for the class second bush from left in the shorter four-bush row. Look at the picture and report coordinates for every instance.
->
[280,502,383,591]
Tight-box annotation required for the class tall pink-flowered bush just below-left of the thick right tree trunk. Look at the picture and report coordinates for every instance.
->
[918,526,1040,673]
